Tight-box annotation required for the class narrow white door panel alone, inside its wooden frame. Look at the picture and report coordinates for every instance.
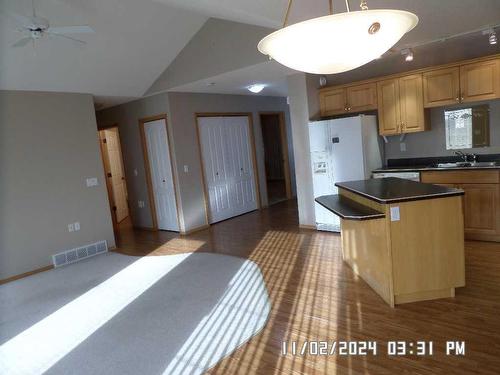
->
[144,119,179,231]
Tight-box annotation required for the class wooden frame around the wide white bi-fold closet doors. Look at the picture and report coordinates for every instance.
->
[194,112,262,225]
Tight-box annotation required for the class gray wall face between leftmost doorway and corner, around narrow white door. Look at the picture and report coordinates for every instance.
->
[96,94,171,228]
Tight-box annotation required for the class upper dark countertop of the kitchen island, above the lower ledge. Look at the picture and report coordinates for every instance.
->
[335,177,464,204]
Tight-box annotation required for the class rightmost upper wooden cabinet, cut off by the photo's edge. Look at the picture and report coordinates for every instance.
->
[460,59,500,102]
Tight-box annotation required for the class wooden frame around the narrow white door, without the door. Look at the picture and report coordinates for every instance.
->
[139,113,182,233]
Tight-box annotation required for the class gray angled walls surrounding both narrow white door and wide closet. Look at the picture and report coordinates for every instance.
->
[97,93,295,231]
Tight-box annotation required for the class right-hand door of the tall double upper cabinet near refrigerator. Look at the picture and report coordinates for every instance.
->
[399,74,426,133]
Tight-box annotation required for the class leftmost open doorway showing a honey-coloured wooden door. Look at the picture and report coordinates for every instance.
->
[99,125,129,229]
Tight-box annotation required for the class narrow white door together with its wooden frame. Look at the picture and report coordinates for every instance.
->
[139,115,180,232]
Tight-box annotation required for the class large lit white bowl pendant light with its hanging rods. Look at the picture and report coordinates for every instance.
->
[257,0,418,74]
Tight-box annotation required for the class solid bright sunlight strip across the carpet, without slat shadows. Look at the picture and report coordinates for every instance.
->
[0,253,191,374]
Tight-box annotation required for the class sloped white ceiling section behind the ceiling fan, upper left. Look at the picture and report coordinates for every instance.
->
[0,0,207,105]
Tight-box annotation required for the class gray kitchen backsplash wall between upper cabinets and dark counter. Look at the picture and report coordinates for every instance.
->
[385,100,500,159]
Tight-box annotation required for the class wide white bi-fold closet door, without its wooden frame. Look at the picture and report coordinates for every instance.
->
[198,116,258,223]
